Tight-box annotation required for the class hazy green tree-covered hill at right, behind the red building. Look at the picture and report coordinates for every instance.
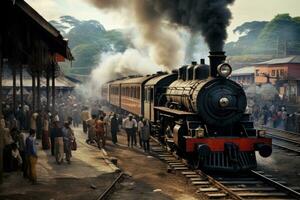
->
[225,14,300,57]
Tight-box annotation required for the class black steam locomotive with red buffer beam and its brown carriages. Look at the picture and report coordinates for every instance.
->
[102,52,272,171]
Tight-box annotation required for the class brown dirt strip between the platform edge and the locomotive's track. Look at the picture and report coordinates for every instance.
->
[106,131,204,200]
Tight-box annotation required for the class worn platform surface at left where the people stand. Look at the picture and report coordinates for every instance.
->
[0,128,119,200]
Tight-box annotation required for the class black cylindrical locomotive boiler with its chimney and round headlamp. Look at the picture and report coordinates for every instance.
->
[166,52,247,127]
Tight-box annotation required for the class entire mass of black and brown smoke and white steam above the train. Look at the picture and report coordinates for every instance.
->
[82,0,234,100]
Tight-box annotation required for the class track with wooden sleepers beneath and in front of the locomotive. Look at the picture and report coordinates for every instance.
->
[151,138,300,200]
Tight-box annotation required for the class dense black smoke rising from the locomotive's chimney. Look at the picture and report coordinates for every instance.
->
[152,0,234,51]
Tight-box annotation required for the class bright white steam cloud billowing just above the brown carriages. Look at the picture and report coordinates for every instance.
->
[76,49,159,99]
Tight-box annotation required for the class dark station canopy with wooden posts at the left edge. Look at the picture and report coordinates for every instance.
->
[0,0,73,113]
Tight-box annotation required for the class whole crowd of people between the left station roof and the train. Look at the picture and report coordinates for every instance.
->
[0,95,154,184]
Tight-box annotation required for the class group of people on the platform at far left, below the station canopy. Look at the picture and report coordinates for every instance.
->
[0,92,80,184]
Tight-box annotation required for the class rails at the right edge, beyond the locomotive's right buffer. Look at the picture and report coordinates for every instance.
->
[264,127,300,154]
